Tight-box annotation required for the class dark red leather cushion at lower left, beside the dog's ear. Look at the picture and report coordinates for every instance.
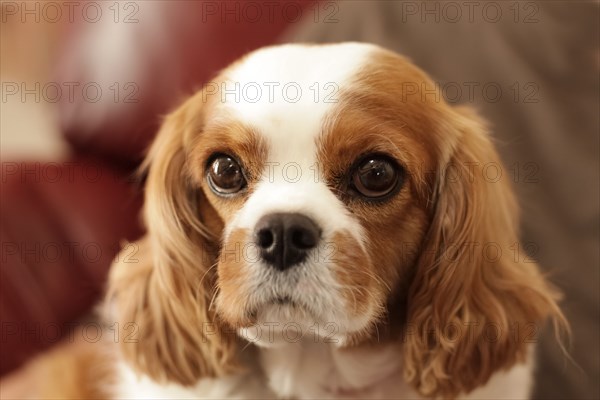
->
[0,158,142,374]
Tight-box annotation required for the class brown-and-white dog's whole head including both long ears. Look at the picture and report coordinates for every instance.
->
[111,43,562,396]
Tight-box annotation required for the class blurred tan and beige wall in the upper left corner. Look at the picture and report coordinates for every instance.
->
[0,1,67,161]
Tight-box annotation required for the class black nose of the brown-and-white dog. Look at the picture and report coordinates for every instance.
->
[255,213,321,271]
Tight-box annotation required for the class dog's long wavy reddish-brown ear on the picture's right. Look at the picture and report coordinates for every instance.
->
[403,110,566,398]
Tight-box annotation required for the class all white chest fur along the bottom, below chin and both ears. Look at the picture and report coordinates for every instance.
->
[114,341,533,399]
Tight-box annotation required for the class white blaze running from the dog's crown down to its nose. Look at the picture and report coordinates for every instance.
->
[220,43,377,244]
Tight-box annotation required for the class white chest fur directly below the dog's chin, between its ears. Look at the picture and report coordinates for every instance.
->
[255,340,409,398]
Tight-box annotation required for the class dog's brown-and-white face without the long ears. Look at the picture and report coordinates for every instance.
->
[197,44,439,346]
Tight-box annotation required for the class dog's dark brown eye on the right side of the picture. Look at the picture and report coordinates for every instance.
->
[352,155,400,198]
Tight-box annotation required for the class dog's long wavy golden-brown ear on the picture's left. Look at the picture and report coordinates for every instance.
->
[106,95,236,385]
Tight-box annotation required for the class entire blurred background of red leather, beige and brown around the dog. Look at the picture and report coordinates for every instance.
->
[0,1,600,399]
